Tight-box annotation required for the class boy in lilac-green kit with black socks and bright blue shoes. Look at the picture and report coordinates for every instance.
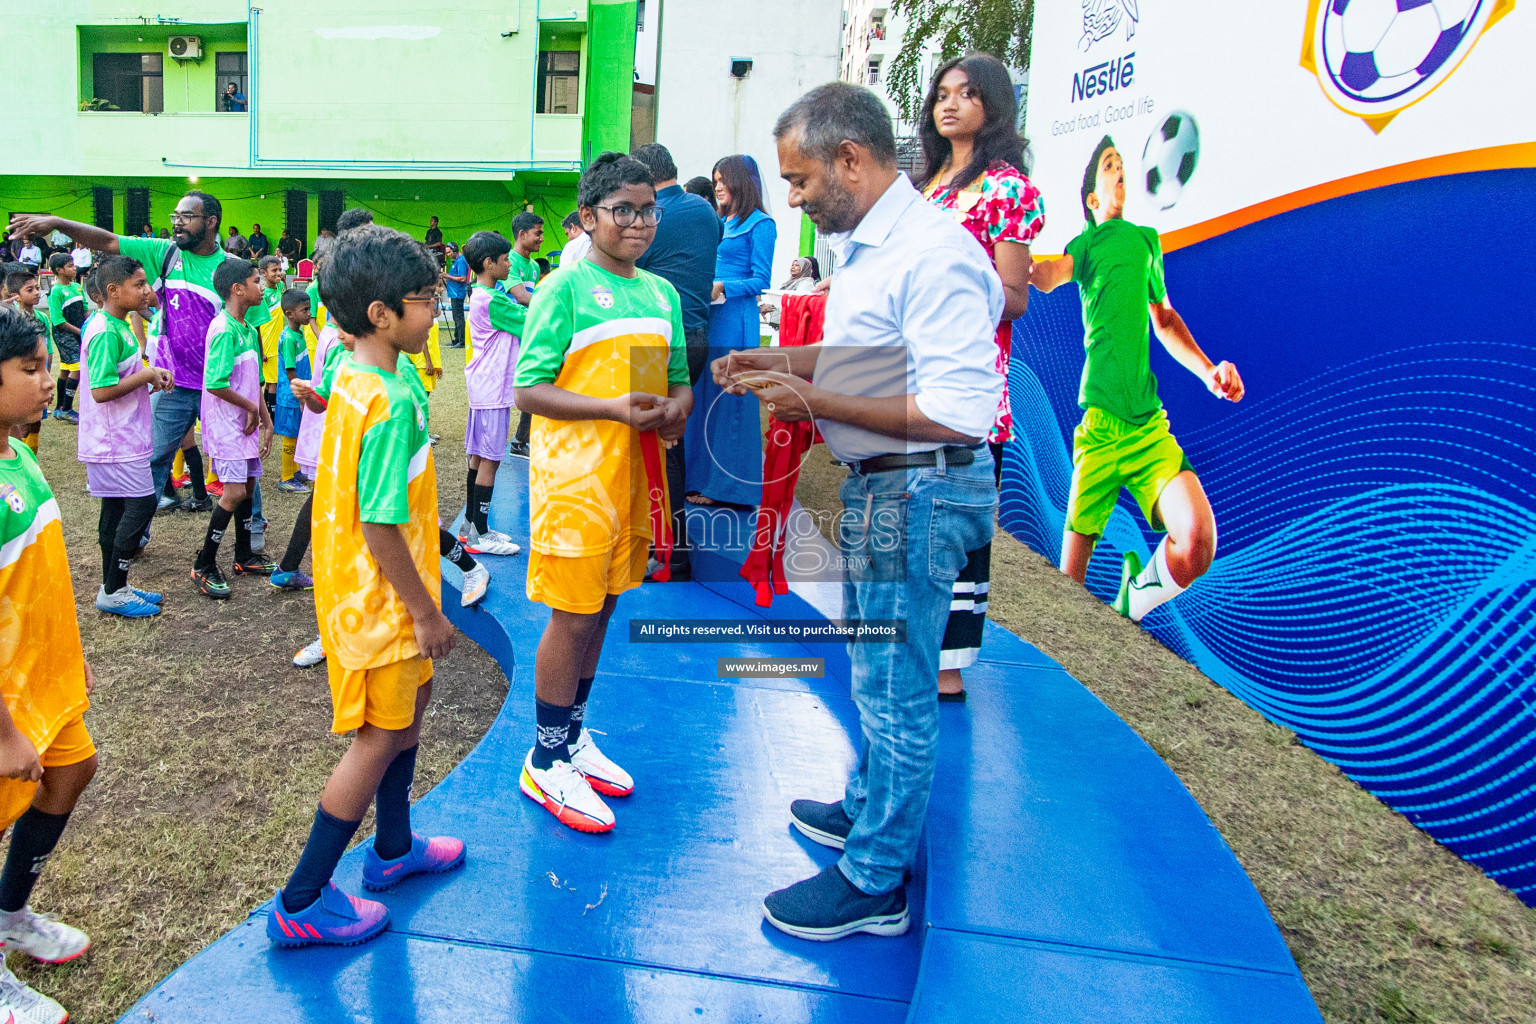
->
[78,256,172,619]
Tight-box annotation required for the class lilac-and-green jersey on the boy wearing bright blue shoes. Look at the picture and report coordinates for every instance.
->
[77,312,154,462]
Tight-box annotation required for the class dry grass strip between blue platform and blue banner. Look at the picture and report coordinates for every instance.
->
[797,445,1536,1024]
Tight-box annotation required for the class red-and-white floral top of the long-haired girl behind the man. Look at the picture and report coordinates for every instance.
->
[923,160,1046,442]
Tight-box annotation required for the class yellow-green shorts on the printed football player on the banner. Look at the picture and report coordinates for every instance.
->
[1066,408,1193,537]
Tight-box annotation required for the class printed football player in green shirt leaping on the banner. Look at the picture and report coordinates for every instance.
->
[1029,135,1243,622]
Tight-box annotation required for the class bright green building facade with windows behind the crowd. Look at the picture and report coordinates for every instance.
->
[0,0,636,257]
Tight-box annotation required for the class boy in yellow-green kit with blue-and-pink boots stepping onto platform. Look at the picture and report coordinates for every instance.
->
[267,224,464,946]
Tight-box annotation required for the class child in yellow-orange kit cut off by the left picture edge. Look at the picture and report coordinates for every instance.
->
[0,309,97,1021]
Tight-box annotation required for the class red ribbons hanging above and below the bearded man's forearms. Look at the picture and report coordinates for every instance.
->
[740,295,826,608]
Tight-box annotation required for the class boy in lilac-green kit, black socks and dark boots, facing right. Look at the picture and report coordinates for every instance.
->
[192,259,278,599]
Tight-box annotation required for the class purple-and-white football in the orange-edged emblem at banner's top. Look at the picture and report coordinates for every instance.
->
[1315,0,1496,117]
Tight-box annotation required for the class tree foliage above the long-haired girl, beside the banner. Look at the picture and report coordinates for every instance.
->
[886,0,1035,118]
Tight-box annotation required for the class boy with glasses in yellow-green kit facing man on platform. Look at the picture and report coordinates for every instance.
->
[516,154,693,832]
